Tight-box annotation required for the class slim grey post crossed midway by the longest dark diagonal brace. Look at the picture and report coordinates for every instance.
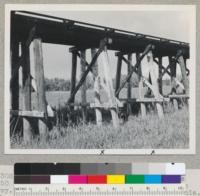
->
[80,50,87,122]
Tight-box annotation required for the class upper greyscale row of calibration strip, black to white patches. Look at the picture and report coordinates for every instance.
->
[14,163,186,175]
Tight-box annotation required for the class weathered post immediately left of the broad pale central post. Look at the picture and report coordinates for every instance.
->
[91,48,102,125]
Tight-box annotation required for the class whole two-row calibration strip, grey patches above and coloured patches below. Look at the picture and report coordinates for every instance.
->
[14,163,185,184]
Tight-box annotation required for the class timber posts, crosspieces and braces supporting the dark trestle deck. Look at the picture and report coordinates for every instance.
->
[10,11,189,142]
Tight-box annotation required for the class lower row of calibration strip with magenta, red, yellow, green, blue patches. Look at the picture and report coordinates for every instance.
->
[14,175,182,184]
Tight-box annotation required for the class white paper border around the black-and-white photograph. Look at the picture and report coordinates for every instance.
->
[4,4,196,155]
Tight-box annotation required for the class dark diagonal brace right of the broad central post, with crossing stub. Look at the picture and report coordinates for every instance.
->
[115,44,155,96]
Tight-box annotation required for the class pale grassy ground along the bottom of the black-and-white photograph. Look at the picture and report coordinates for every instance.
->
[11,108,189,149]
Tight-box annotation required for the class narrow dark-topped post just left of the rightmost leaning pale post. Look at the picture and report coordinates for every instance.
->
[169,56,178,110]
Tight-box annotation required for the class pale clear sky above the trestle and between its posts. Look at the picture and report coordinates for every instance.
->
[28,10,191,79]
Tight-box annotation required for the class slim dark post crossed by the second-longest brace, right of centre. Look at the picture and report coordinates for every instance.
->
[127,53,132,114]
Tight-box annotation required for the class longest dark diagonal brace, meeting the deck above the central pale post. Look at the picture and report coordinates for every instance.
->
[67,39,112,104]
